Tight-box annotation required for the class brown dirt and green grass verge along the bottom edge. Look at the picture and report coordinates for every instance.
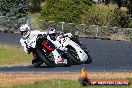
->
[0,72,132,88]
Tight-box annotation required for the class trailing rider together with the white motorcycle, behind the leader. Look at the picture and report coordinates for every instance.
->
[48,28,92,64]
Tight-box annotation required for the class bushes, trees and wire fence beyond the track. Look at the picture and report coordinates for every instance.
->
[0,0,132,41]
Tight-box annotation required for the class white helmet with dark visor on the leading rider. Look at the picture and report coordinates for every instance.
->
[19,24,30,38]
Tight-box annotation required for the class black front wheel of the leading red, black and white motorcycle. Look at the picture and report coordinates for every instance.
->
[38,50,55,67]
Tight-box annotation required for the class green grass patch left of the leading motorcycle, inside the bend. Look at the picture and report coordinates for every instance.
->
[0,44,32,65]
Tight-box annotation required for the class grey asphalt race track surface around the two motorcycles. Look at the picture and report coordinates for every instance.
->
[0,33,132,72]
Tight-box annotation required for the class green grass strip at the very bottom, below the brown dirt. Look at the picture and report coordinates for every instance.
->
[11,80,132,88]
